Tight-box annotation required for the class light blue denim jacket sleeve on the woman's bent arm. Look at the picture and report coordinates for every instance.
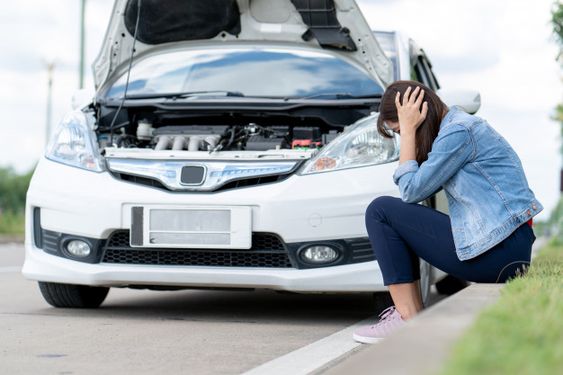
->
[393,124,475,203]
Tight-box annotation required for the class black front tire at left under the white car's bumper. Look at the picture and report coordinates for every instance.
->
[39,281,109,309]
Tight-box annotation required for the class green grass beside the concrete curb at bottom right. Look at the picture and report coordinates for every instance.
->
[442,241,563,375]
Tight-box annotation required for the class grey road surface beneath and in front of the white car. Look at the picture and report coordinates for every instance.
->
[0,244,446,375]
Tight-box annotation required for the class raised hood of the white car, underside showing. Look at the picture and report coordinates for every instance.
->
[93,0,393,88]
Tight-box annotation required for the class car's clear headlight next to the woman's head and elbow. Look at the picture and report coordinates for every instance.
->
[299,114,399,175]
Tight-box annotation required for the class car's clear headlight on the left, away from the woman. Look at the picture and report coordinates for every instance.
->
[45,110,105,172]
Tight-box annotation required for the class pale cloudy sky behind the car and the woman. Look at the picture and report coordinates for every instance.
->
[0,0,563,220]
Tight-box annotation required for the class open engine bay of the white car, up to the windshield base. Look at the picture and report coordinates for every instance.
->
[91,92,378,159]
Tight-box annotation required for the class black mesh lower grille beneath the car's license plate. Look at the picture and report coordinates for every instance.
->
[102,230,293,268]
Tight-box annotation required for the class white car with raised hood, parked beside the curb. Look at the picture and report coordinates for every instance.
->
[22,0,479,307]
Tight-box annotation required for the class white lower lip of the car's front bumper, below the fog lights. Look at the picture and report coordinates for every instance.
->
[23,250,384,292]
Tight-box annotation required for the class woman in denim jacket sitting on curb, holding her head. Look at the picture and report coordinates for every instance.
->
[354,81,543,343]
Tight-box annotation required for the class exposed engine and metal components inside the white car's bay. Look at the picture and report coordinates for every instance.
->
[96,111,342,154]
